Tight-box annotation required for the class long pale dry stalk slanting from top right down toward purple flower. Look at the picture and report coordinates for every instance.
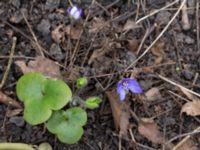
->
[125,0,186,71]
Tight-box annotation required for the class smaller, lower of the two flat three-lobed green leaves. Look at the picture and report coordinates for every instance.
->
[47,107,87,144]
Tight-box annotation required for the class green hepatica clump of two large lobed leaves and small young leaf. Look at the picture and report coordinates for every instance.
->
[16,73,101,144]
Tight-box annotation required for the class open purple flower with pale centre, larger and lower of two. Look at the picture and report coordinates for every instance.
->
[117,78,142,101]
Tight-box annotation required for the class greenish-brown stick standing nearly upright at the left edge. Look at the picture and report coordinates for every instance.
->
[0,37,17,89]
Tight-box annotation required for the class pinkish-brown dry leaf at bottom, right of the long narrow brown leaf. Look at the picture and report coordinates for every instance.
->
[138,119,164,144]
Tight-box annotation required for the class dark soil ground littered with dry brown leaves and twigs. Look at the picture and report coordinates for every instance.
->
[0,0,200,150]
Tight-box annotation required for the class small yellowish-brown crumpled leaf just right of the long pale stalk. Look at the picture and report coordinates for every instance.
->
[151,41,165,64]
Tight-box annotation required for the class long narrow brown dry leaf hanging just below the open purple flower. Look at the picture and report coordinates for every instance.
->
[106,90,130,136]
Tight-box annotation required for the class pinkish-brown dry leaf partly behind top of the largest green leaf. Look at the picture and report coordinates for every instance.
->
[15,56,62,79]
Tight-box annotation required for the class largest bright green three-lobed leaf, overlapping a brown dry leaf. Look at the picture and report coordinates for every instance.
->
[16,73,72,125]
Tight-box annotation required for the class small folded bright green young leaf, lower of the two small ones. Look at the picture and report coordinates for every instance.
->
[85,96,102,109]
